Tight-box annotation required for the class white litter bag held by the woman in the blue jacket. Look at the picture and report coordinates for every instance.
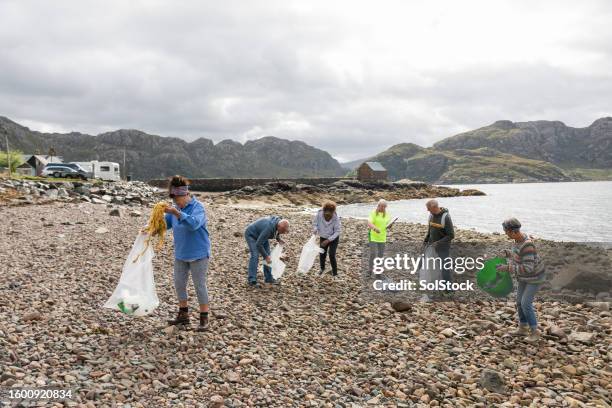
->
[104,233,159,316]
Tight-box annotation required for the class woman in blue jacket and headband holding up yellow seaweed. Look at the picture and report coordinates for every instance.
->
[165,176,210,331]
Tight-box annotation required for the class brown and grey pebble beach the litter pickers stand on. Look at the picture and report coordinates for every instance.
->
[0,197,612,407]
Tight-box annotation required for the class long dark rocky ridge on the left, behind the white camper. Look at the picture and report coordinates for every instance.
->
[0,116,346,180]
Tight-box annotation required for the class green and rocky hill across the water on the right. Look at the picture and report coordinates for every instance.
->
[357,118,612,184]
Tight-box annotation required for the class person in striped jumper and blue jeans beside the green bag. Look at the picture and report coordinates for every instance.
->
[497,218,545,343]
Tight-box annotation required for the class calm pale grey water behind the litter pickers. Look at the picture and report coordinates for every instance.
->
[338,181,612,242]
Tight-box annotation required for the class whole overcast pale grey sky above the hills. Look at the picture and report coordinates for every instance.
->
[0,0,612,160]
